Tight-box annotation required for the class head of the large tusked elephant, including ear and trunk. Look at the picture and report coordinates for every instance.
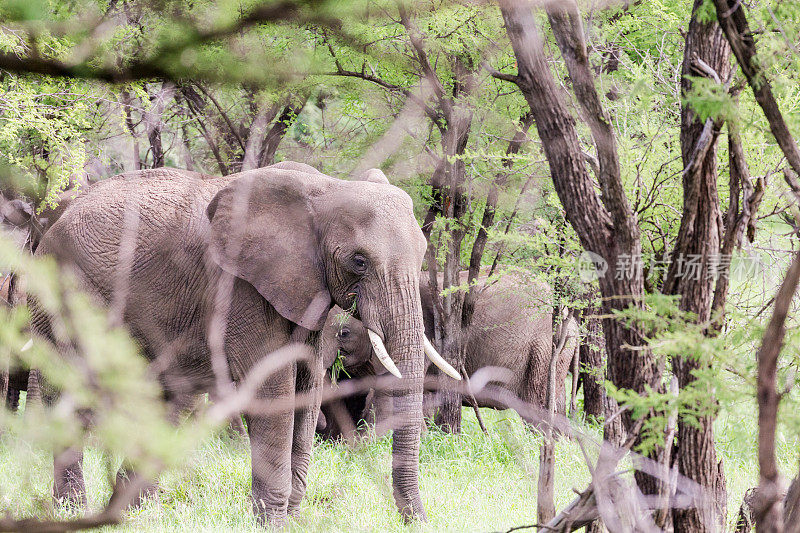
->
[206,163,456,518]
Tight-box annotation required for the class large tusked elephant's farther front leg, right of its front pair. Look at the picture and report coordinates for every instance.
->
[289,356,325,513]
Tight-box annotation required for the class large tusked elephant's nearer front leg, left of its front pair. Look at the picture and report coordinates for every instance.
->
[245,366,295,527]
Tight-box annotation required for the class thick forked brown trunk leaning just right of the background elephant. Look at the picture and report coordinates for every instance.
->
[500,0,661,500]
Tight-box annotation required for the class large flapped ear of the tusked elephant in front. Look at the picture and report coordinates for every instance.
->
[206,171,331,331]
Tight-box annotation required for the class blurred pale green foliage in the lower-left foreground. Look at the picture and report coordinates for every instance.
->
[0,237,234,508]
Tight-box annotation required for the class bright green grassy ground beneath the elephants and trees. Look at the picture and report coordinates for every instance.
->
[0,401,797,531]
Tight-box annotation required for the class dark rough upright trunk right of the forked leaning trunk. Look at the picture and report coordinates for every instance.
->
[664,0,731,532]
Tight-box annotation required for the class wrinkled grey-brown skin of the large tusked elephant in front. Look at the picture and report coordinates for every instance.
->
[33,163,432,524]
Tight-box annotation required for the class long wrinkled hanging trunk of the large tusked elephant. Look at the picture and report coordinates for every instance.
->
[382,283,426,520]
